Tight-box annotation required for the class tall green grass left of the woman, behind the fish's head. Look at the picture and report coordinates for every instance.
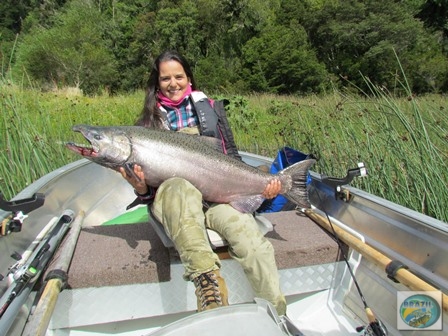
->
[0,79,138,198]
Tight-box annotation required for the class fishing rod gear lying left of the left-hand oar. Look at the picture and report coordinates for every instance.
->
[0,210,74,335]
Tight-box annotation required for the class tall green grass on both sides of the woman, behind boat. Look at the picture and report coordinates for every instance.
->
[0,80,448,222]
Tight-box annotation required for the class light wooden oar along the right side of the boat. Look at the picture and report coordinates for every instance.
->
[305,209,448,312]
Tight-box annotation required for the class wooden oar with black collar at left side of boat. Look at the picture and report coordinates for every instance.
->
[22,211,85,336]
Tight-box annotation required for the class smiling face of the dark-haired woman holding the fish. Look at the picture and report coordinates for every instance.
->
[159,60,190,102]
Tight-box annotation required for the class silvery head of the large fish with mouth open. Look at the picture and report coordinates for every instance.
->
[66,125,132,170]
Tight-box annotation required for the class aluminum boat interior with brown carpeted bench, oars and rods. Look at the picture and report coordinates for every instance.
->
[0,152,448,336]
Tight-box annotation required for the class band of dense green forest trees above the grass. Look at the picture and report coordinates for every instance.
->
[0,0,448,94]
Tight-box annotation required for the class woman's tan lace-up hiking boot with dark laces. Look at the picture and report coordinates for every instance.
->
[193,270,229,312]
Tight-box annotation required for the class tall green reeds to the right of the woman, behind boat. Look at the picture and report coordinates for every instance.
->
[230,85,448,222]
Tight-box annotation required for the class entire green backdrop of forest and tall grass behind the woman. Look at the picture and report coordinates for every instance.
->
[0,0,448,222]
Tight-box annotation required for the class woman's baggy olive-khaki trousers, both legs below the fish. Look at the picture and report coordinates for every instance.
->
[152,177,286,315]
